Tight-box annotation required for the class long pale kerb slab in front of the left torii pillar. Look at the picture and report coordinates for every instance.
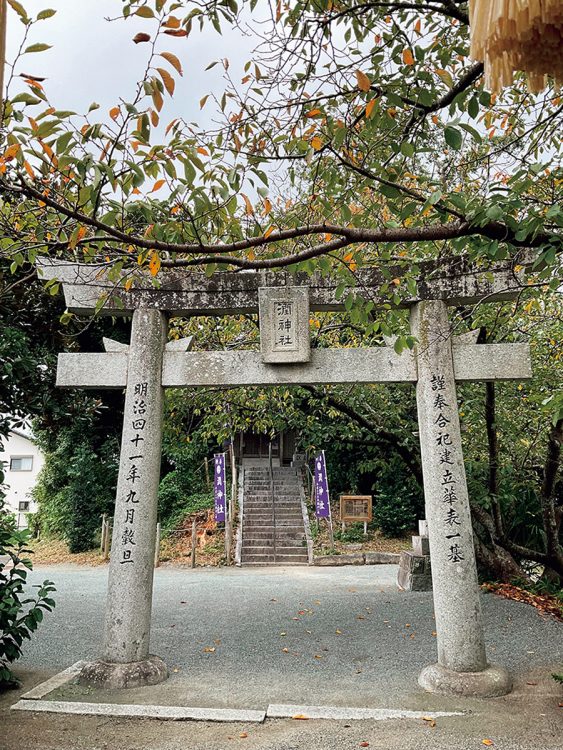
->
[11,701,266,724]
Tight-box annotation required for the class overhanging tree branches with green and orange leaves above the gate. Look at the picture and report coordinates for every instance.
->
[0,0,563,300]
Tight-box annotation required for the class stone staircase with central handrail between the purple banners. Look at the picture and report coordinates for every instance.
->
[241,467,308,565]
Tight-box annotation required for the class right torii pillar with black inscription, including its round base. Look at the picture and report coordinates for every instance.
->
[411,300,512,697]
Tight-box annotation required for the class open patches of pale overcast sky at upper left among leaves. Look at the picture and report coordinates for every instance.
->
[6,0,252,128]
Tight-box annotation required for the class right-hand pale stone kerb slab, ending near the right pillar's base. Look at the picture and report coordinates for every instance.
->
[266,704,463,721]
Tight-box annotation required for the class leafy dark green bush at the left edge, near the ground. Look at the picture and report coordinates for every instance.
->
[0,510,55,689]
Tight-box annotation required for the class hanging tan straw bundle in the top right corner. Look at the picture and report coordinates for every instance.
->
[469,0,563,94]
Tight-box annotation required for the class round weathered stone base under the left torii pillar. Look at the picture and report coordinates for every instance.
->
[78,656,168,689]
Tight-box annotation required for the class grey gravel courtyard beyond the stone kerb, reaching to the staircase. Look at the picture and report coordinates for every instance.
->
[15,565,563,708]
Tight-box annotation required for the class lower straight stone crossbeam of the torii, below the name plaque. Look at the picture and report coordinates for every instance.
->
[57,344,531,388]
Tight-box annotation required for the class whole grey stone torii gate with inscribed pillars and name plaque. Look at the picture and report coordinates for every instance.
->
[38,259,531,696]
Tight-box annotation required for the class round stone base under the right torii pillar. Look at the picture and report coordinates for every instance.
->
[418,664,512,698]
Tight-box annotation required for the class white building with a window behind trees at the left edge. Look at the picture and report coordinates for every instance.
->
[0,428,45,529]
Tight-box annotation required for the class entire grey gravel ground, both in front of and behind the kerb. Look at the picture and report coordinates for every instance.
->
[0,566,563,750]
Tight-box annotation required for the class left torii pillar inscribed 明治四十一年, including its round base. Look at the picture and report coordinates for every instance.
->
[79,308,168,688]
